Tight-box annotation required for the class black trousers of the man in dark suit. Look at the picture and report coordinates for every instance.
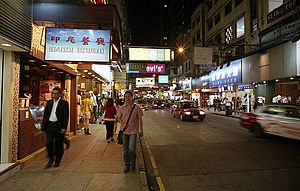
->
[46,123,64,163]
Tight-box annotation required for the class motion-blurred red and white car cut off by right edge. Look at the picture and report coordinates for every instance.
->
[241,104,300,140]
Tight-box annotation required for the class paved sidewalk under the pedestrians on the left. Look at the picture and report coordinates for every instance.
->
[0,124,148,191]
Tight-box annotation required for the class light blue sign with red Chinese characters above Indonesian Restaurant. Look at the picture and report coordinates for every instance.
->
[45,28,110,62]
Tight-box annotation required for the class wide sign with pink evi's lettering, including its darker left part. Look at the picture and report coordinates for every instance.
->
[126,63,165,74]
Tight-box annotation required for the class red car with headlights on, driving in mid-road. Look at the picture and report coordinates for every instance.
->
[171,100,206,121]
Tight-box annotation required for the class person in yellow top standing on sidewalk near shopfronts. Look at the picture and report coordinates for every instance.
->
[81,92,93,135]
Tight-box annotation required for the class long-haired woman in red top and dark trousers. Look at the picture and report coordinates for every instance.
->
[104,98,117,143]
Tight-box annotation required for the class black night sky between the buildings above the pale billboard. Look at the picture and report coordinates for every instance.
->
[128,0,202,46]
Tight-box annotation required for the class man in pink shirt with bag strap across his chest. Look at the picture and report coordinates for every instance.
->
[117,91,143,173]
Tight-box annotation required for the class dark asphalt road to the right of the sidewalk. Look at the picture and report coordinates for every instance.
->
[143,109,300,191]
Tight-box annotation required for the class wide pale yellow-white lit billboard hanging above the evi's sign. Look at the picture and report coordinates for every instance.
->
[129,48,171,61]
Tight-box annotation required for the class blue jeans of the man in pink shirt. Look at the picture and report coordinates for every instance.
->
[123,133,137,166]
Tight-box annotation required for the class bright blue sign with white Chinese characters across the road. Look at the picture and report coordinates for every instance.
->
[209,60,242,87]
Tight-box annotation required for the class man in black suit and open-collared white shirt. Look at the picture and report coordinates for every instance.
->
[42,87,69,168]
